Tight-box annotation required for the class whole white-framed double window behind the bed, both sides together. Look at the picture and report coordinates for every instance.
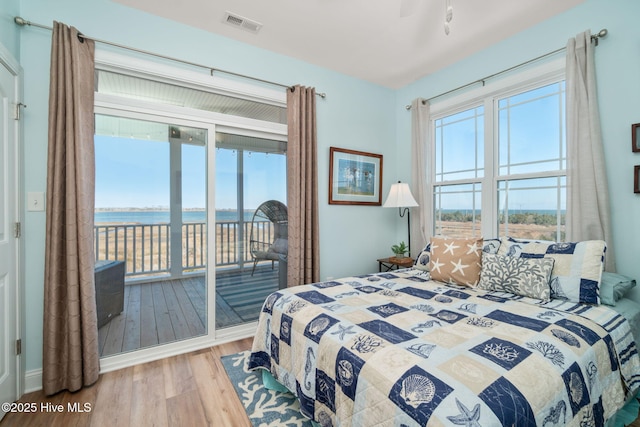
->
[432,66,567,241]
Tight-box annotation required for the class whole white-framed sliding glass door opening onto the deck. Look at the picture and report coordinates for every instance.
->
[90,58,287,368]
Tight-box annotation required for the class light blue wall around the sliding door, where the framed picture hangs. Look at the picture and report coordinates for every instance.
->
[17,0,397,370]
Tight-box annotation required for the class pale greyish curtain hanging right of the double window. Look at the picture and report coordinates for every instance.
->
[566,30,616,272]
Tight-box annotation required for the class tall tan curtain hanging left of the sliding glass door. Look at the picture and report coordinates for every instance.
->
[42,22,100,395]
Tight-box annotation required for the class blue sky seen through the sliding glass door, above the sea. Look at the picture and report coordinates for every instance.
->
[95,135,286,209]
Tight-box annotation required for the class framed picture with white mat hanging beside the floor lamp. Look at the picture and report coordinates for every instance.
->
[329,147,382,206]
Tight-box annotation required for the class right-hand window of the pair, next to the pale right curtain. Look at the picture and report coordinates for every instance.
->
[497,81,566,241]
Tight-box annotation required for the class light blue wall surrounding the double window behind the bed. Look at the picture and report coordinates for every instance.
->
[395,0,640,301]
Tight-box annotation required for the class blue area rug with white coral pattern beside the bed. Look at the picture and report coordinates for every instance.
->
[221,351,312,427]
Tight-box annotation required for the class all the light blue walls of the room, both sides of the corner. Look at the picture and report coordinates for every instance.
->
[8,0,640,370]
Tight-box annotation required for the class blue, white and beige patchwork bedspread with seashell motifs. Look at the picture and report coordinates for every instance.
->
[249,270,640,427]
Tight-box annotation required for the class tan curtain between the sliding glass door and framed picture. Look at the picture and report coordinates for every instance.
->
[287,86,320,286]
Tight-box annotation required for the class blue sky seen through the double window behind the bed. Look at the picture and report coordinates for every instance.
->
[435,82,566,211]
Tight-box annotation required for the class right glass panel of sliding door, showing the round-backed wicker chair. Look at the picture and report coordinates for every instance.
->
[215,131,287,328]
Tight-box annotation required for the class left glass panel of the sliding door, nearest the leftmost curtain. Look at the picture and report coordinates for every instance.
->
[95,114,213,356]
